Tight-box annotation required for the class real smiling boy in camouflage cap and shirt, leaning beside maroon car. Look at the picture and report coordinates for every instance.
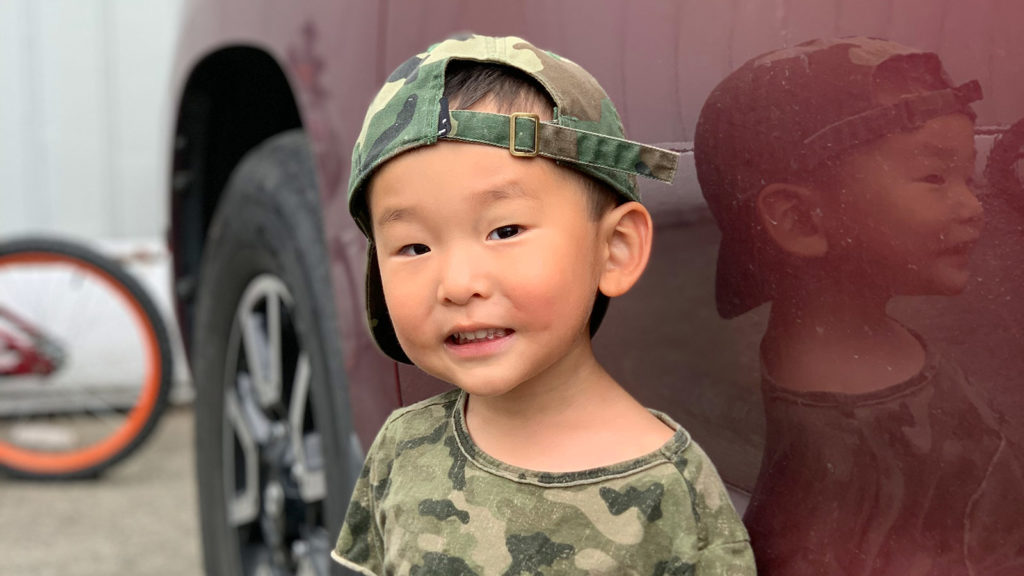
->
[333,36,754,575]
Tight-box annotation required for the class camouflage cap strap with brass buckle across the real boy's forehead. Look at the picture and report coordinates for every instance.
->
[444,110,679,182]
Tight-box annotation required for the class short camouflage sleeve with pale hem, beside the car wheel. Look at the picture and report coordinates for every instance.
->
[331,420,391,576]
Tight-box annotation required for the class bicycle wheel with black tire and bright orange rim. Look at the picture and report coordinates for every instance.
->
[0,239,171,479]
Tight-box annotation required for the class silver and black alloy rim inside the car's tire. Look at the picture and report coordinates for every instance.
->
[221,274,330,575]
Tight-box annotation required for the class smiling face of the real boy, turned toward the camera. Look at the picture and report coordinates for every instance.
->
[370,142,602,396]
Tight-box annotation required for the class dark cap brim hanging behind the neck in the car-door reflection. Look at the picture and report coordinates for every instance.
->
[715,227,770,320]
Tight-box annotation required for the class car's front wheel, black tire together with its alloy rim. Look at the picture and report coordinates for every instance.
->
[193,131,361,576]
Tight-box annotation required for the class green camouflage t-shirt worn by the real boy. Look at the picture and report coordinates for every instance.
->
[332,390,756,576]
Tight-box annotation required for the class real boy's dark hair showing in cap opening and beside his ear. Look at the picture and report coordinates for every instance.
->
[444,60,626,220]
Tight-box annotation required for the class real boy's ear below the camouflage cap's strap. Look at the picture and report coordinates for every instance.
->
[598,202,654,298]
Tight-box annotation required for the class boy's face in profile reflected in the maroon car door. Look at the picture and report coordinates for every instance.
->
[825,114,982,294]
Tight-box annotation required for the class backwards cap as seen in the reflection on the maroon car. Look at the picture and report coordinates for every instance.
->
[693,37,981,318]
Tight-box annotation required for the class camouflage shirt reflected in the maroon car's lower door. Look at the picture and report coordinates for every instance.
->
[744,338,1024,576]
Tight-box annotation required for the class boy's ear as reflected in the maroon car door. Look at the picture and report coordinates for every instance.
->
[757,183,828,258]
